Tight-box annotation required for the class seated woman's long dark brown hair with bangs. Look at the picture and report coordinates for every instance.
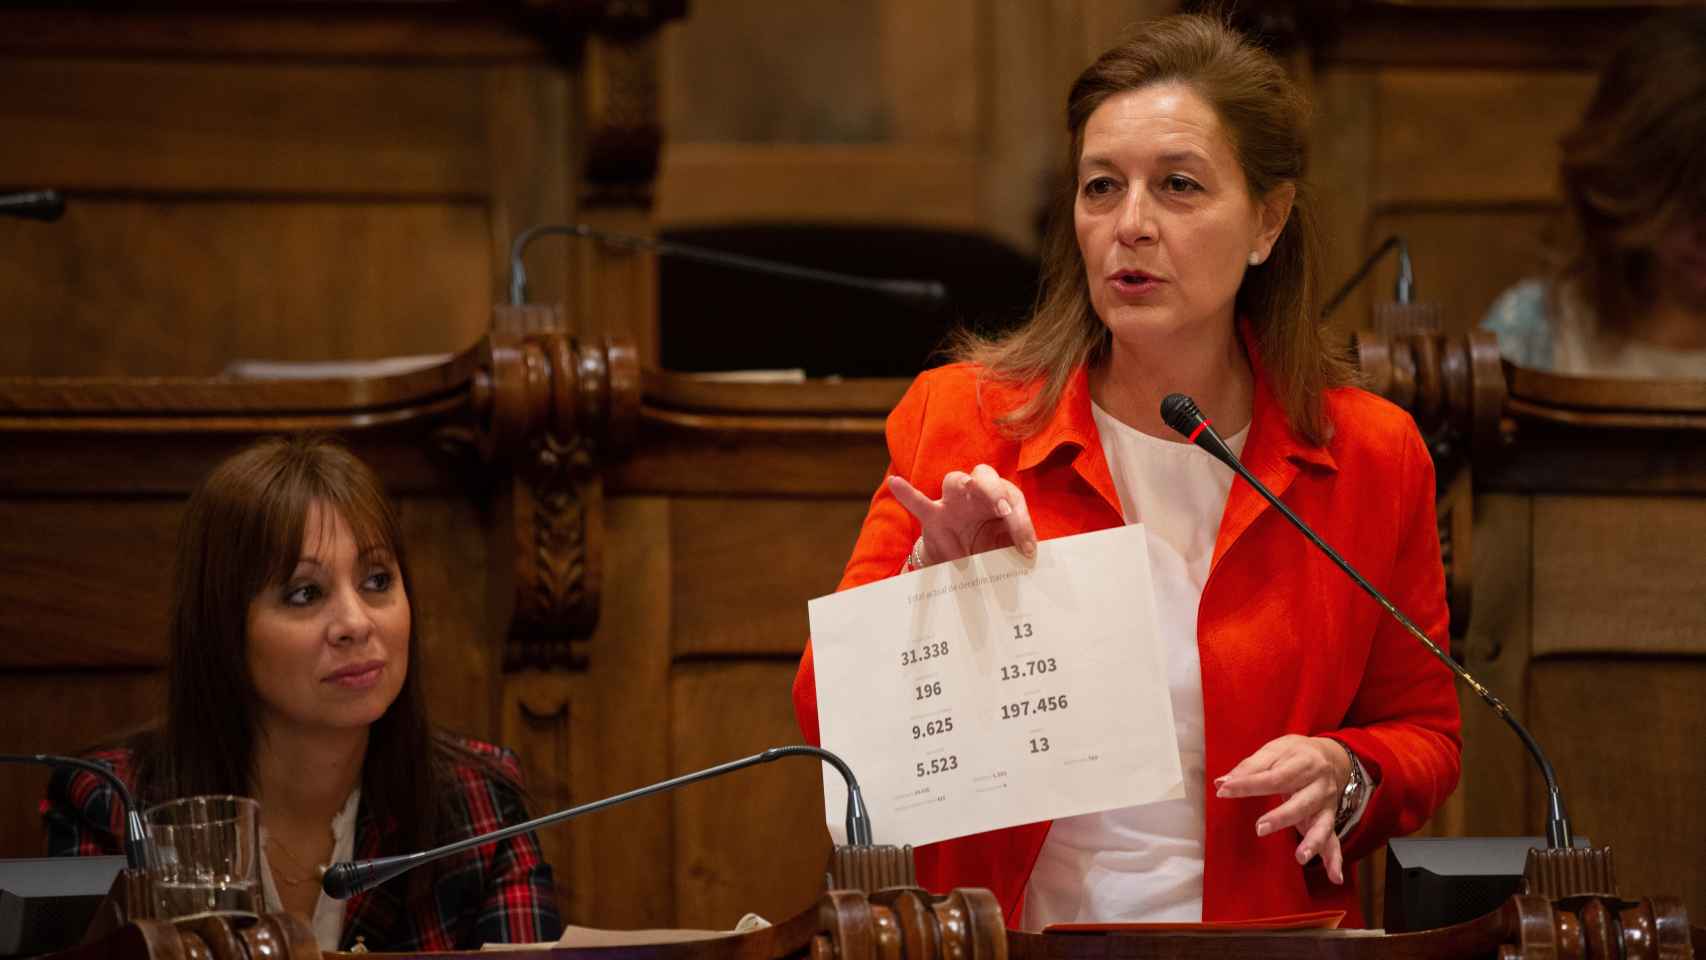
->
[138,437,485,853]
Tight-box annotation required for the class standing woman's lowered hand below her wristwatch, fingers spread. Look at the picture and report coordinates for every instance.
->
[1215,733,1351,883]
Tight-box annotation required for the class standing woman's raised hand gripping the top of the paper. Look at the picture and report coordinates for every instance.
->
[889,464,1037,563]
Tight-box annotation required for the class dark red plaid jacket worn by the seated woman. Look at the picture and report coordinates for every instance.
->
[41,740,563,953]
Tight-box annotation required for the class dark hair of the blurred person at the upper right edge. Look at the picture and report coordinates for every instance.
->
[1558,9,1706,331]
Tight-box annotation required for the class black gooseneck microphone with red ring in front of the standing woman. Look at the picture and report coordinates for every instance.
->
[1162,394,1575,849]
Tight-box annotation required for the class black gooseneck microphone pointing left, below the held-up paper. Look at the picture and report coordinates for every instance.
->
[321,745,872,900]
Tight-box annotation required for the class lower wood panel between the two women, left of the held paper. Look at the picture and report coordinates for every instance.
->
[670,662,829,929]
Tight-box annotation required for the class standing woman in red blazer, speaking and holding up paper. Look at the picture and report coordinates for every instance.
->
[793,17,1460,926]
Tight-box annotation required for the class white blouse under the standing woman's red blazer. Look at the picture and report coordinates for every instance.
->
[1020,404,1249,931]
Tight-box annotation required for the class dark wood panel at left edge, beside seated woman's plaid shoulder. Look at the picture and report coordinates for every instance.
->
[0,670,165,858]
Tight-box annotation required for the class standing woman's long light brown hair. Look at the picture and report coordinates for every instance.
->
[949,14,1351,443]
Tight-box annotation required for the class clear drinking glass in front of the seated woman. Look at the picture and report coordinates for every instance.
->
[143,796,261,919]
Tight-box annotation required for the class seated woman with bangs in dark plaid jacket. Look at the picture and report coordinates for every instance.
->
[43,438,561,951]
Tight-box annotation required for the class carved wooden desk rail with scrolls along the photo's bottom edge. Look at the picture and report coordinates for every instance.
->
[36,888,1706,960]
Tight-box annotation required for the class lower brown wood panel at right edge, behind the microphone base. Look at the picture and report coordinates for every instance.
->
[1529,656,1706,917]
